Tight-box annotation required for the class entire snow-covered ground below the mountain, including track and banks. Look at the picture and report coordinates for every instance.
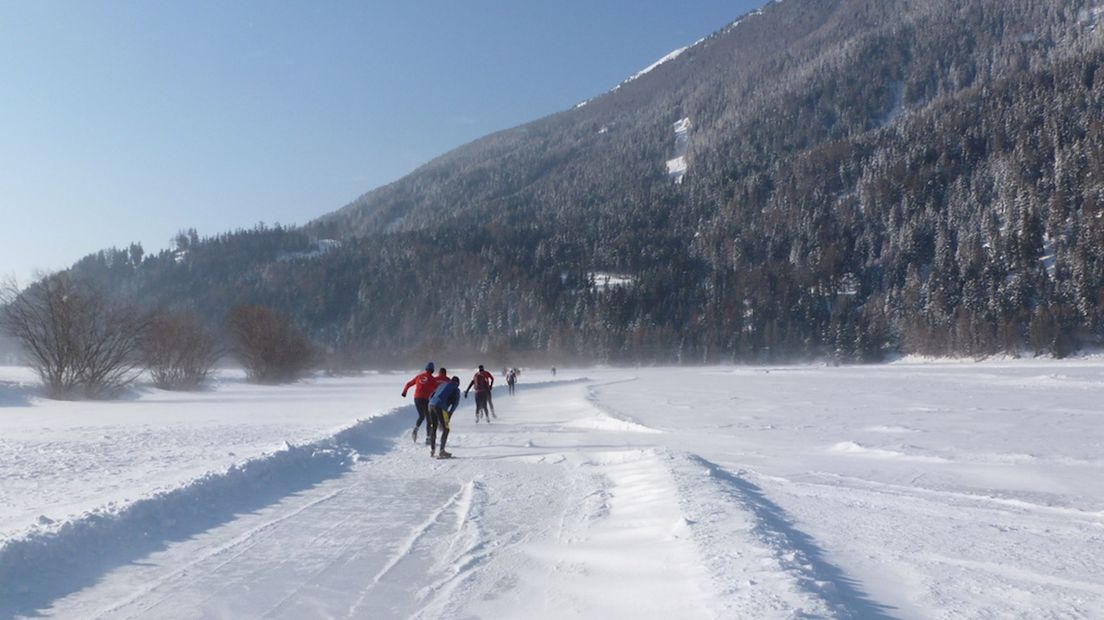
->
[0,359,1104,620]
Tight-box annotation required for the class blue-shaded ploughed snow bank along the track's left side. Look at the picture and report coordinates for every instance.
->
[0,407,412,617]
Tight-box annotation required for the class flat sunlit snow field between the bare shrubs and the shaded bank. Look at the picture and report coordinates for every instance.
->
[0,367,413,543]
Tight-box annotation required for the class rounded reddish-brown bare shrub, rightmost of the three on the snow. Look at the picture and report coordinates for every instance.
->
[226,306,315,383]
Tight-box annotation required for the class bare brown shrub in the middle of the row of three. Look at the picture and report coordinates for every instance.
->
[139,311,222,389]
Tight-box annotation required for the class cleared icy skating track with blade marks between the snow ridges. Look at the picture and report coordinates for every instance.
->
[10,382,880,619]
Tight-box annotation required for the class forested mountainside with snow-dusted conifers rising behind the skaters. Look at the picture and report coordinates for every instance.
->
[23,0,1104,362]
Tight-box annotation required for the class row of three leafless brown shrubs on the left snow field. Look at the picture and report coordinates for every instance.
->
[0,272,316,399]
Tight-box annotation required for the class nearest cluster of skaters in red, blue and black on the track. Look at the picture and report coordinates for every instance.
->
[403,362,519,459]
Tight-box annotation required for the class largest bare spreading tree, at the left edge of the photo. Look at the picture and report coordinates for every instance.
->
[0,274,144,399]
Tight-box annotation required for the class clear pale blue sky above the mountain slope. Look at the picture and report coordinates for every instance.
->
[0,0,763,284]
